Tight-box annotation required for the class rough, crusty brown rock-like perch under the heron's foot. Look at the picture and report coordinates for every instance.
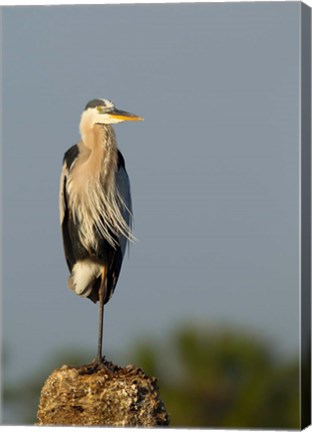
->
[37,362,169,427]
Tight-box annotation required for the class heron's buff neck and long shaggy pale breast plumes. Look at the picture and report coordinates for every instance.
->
[68,121,133,249]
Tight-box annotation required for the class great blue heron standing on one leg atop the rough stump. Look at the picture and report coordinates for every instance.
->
[60,99,143,364]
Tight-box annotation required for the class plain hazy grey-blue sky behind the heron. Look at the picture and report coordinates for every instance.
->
[2,2,300,386]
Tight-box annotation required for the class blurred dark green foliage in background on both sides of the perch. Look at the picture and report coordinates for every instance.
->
[3,325,300,429]
